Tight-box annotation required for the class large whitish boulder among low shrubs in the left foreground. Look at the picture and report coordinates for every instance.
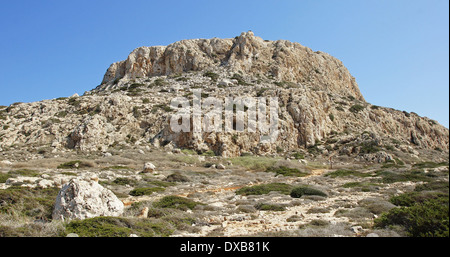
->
[52,179,124,220]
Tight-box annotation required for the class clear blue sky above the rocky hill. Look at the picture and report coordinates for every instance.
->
[0,0,449,127]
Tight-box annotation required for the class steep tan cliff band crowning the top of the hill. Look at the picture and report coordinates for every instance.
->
[102,31,364,100]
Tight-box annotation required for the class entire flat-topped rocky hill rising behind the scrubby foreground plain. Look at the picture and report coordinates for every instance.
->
[0,32,449,157]
